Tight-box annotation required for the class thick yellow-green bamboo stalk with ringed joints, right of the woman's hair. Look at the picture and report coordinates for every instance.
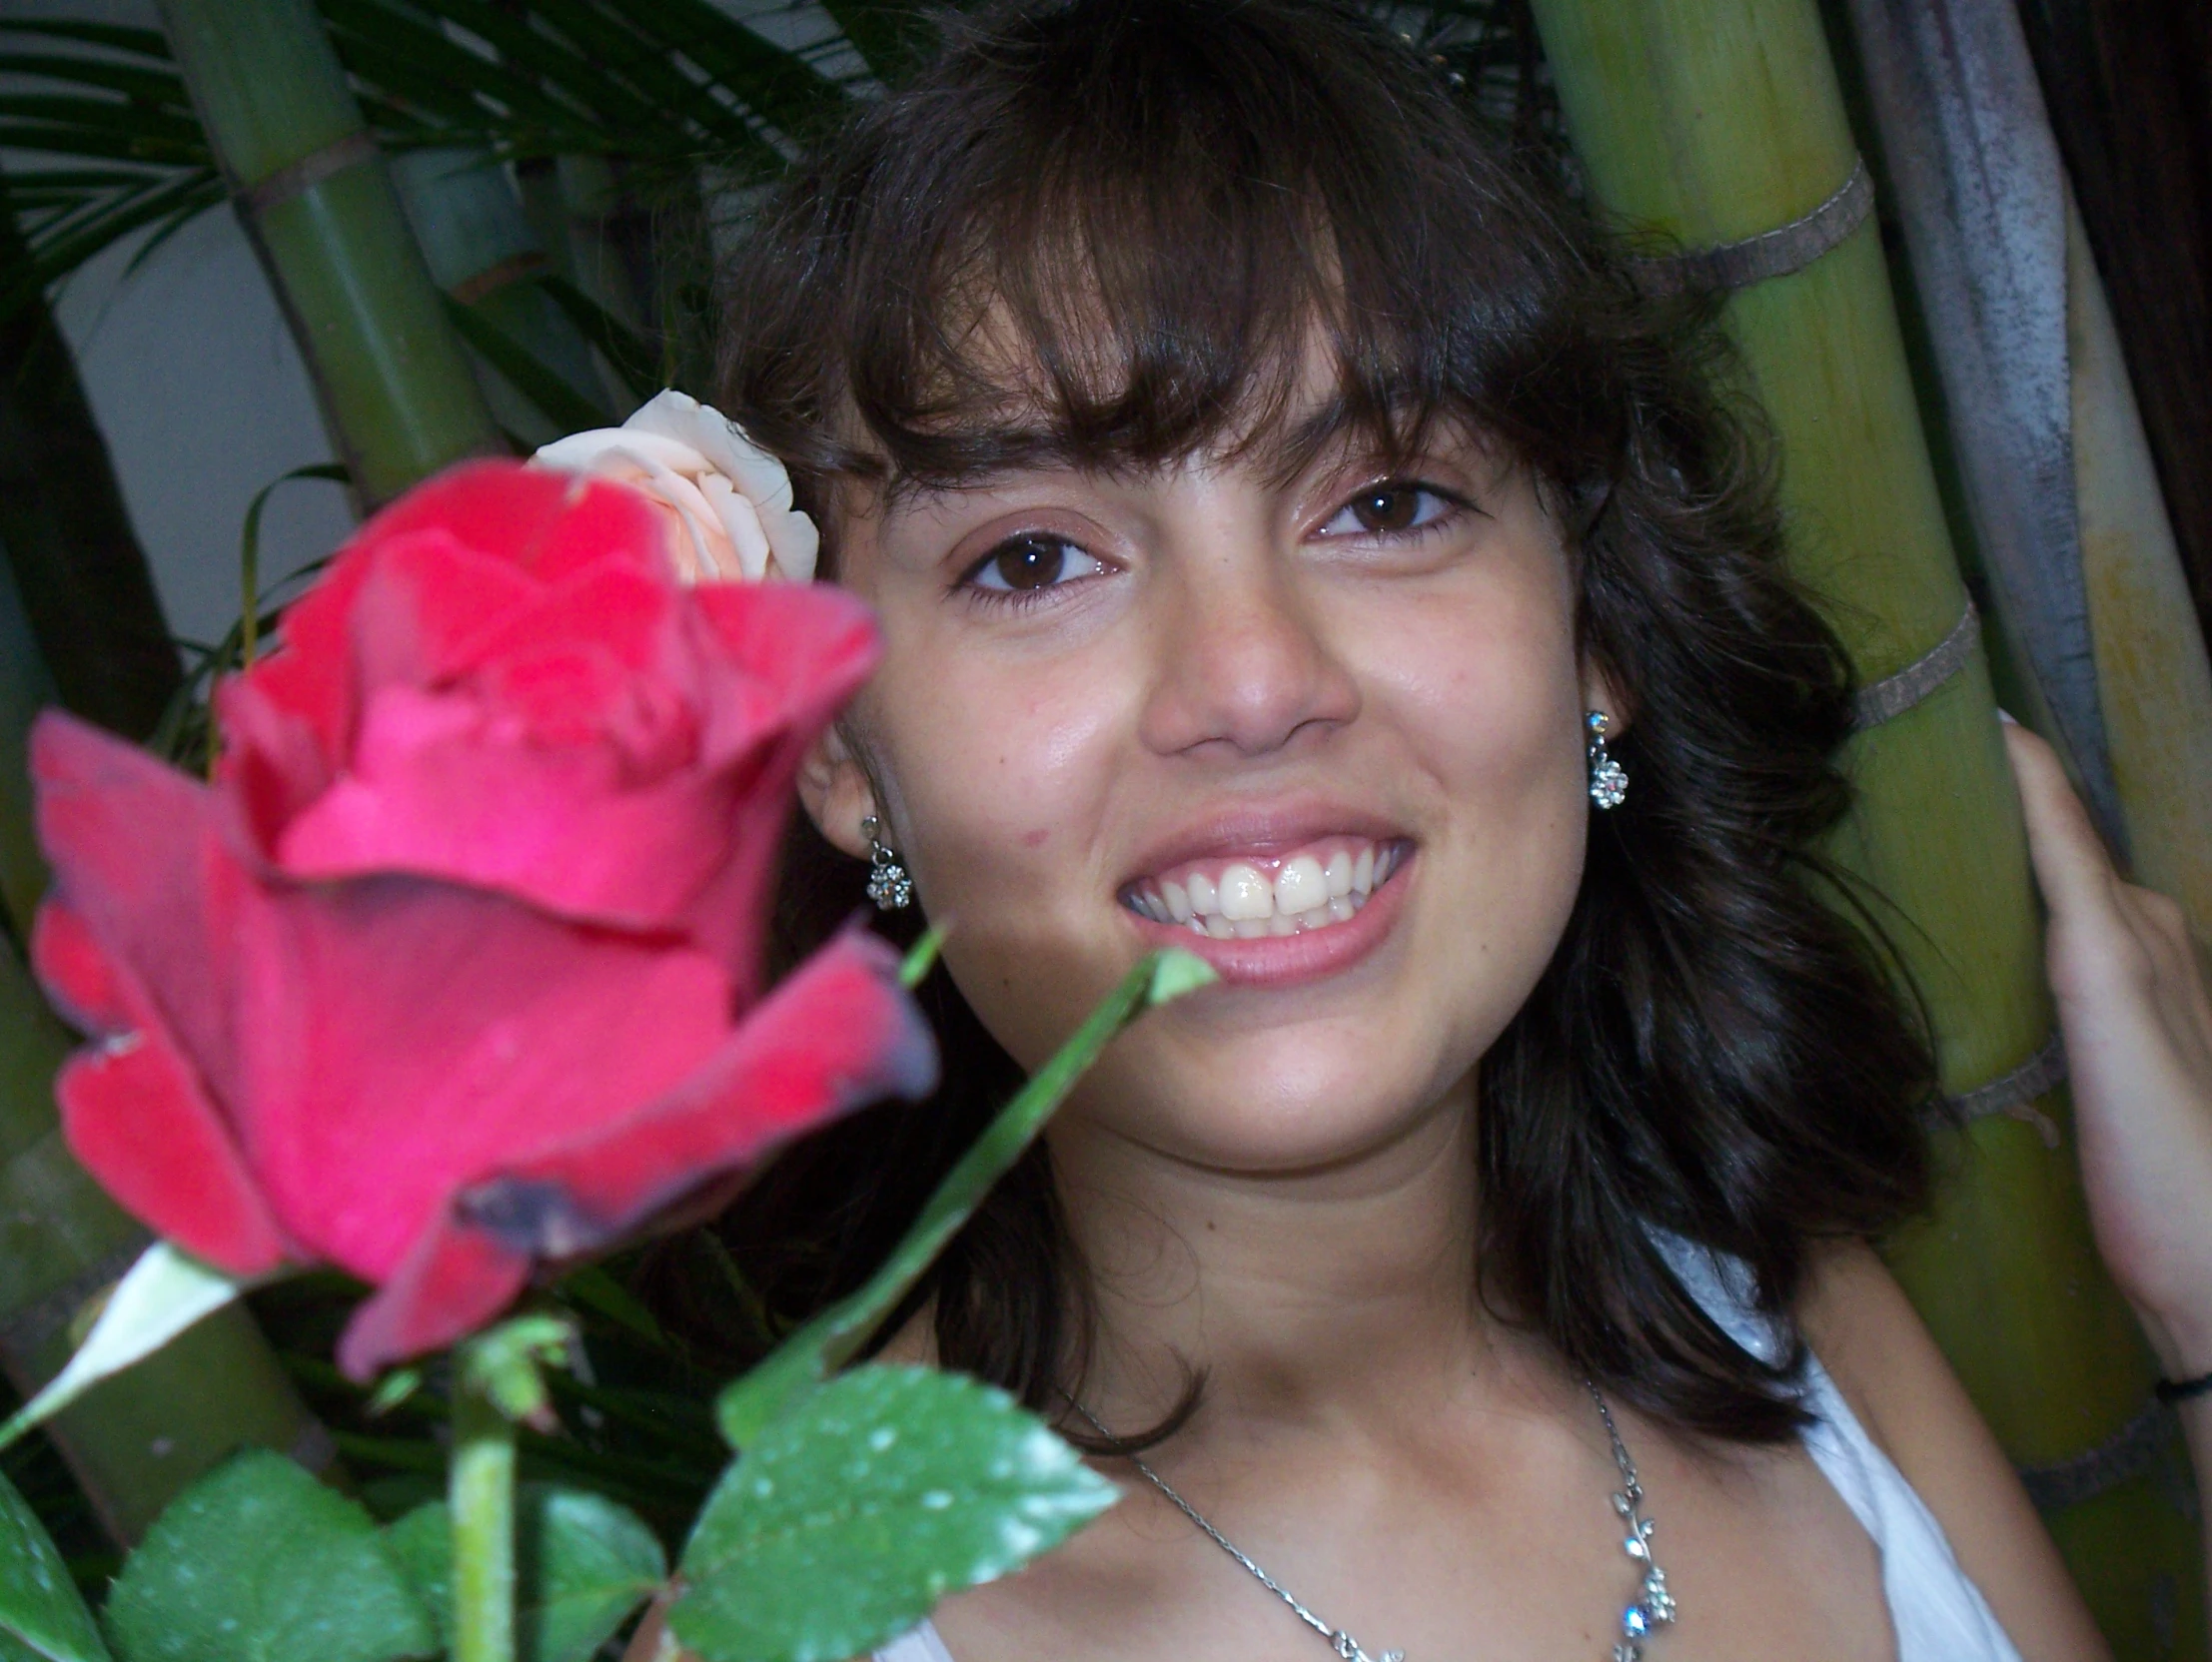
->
[1533,0,2201,1655]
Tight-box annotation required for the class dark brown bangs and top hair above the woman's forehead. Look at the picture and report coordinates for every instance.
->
[730,7,1593,505]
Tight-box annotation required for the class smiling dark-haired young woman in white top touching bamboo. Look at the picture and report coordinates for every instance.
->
[698,0,2212,1662]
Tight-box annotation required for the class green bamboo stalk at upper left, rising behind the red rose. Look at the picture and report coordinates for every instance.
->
[162,0,505,506]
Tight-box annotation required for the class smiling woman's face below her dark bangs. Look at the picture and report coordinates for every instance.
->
[805,416,1613,1174]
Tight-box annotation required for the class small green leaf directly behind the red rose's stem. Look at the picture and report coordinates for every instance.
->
[385,1483,668,1662]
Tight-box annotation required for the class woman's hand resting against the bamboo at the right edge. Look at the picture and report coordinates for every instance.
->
[2004,725,2212,1379]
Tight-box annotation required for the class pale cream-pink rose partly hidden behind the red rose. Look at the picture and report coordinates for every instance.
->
[531,392,820,583]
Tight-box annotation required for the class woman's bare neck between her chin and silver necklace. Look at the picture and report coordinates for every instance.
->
[1053,1081,1498,1430]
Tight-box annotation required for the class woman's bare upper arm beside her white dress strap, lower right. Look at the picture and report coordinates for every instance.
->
[1798,1243,2110,1662]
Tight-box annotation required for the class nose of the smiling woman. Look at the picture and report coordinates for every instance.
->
[1144,534,1361,756]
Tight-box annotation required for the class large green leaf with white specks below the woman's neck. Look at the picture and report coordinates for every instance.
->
[670,1365,1115,1662]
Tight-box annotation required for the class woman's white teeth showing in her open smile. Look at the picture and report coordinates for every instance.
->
[1121,838,1414,942]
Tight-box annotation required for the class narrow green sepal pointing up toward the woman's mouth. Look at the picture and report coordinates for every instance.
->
[714,946,1214,1447]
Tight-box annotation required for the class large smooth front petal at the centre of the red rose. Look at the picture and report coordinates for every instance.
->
[228,877,732,1279]
